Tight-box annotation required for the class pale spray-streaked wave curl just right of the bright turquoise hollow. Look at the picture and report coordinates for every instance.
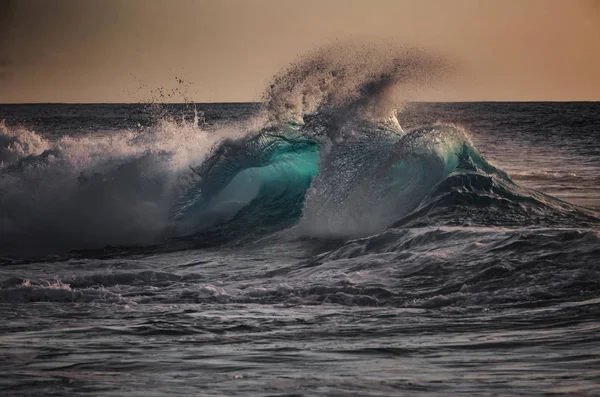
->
[296,125,470,238]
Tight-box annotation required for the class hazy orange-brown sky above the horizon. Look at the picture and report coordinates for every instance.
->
[0,0,600,103]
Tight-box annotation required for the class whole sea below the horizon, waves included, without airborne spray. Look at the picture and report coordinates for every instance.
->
[0,102,600,397]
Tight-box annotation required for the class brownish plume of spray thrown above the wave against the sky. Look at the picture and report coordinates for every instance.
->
[262,43,450,123]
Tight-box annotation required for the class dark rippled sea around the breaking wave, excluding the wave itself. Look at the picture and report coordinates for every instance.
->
[0,103,600,396]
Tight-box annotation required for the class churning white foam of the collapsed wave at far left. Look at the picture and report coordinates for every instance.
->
[0,113,228,255]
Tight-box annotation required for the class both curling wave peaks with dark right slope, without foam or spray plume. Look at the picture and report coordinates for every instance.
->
[166,124,596,244]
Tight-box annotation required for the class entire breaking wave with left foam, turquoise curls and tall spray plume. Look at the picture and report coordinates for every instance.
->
[0,46,597,256]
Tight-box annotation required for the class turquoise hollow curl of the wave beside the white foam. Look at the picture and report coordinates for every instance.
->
[171,127,320,240]
